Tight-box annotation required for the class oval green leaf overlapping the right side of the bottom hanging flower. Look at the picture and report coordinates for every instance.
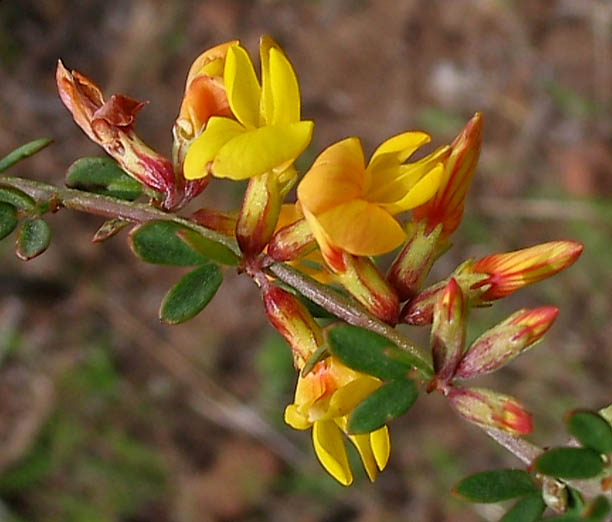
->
[347,379,419,433]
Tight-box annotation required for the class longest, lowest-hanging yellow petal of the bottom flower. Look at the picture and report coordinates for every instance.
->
[312,420,353,486]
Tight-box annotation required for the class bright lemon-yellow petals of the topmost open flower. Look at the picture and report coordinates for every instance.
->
[184,36,313,183]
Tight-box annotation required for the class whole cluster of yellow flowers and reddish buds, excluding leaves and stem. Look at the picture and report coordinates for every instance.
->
[57,36,582,485]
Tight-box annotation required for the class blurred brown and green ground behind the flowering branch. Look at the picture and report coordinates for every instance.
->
[0,0,612,522]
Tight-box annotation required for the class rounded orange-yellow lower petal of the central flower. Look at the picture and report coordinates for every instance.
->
[318,199,406,256]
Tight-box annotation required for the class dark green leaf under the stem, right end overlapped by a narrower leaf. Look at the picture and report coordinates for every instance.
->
[129,221,206,266]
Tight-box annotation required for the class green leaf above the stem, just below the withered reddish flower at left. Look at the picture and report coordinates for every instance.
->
[66,158,142,201]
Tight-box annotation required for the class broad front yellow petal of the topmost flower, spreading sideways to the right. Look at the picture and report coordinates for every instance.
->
[212,121,313,180]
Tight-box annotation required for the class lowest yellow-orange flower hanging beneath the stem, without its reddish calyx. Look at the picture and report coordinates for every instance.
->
[285,357,391,486]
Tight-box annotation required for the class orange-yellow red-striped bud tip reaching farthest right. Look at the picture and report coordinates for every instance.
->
[470,241,584,302]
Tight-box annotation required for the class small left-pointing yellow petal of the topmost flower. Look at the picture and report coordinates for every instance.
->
[183,116,244,179]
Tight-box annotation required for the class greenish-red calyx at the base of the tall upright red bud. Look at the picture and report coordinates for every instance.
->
[387,223,442,301]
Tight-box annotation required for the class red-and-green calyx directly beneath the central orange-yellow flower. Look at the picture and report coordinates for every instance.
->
[335,252,399,325]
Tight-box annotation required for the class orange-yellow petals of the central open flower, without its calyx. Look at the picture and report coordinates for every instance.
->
[298,131,449,256]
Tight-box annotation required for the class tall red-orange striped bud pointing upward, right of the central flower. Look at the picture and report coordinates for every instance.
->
[412,113,482,238]
